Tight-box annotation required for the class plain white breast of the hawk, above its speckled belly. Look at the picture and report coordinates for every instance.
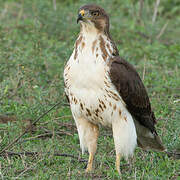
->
[65,32,108,93]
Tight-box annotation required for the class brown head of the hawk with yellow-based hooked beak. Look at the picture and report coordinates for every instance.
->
[77,5,109,32]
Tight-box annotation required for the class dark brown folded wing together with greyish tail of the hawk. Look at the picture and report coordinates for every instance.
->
[110,56,165,151]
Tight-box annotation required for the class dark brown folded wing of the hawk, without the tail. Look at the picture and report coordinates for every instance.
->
[110,56,156,133]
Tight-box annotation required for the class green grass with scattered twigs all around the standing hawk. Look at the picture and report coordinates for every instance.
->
[0,0,180,180]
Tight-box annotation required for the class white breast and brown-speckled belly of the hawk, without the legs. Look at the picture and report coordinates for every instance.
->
[64,31,123,125]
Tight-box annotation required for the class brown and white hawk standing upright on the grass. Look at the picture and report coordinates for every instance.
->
[64,5,164,174]
